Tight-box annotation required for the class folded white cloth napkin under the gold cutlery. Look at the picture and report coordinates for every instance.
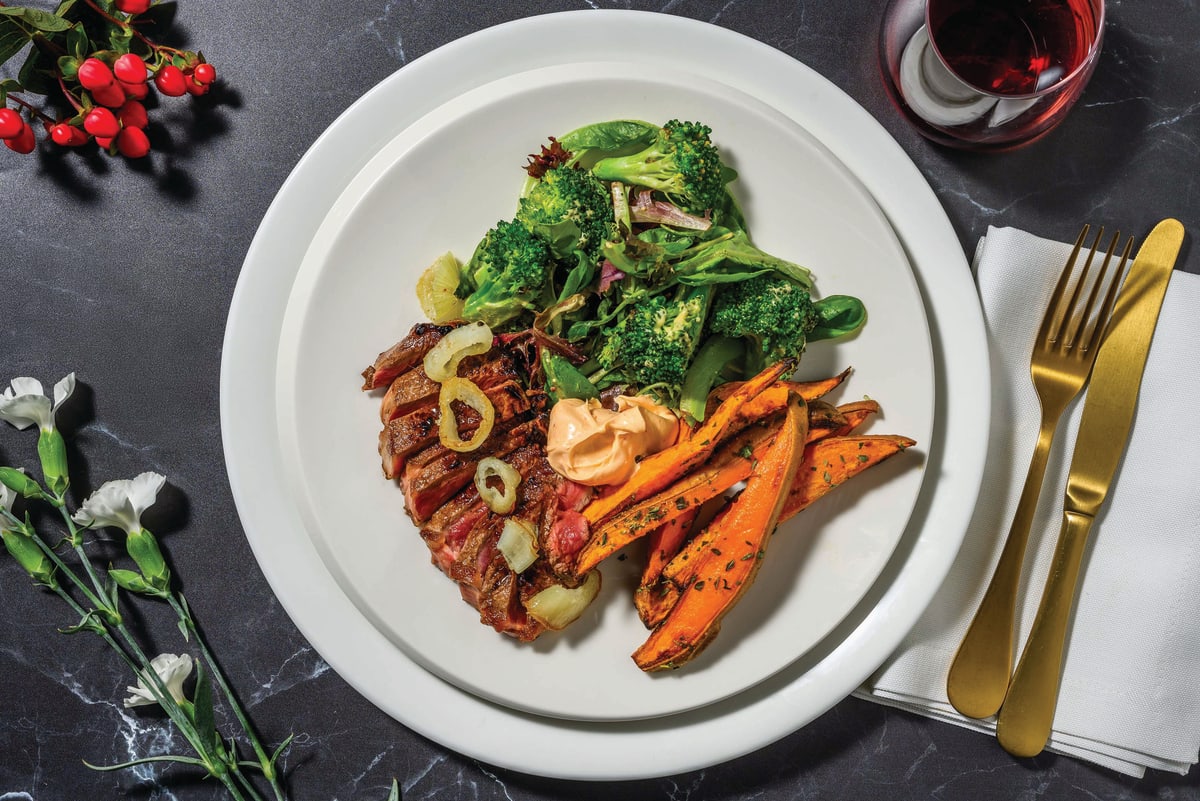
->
[856,228,1200,777]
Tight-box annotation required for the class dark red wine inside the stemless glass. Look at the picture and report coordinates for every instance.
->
[928,0,1098,97]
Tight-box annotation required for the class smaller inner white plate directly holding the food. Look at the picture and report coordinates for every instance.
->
[276,62,935,721]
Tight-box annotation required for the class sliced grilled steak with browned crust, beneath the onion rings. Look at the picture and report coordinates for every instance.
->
[362,324,590,642]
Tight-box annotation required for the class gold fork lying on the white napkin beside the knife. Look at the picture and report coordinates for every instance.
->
[946,225,1133,718]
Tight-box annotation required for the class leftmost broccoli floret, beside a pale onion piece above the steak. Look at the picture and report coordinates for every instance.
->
[458,221,554,329]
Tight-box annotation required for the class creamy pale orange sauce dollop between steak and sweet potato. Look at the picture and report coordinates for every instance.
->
[546,395,679,487]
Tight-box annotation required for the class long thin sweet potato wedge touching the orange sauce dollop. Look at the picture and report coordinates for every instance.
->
[583,361,792,526]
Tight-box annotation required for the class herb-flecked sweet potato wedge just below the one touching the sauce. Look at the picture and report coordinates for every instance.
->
[575,421,779,576]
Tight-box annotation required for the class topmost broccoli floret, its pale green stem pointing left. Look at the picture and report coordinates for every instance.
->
[592,120,726,213]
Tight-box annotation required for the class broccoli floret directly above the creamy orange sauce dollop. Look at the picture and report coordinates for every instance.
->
[595,287,712,406]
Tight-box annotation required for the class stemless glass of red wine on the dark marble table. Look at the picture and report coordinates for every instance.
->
[880,0,1104,150]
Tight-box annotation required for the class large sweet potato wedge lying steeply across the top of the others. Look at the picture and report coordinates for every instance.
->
[634,395,809,670]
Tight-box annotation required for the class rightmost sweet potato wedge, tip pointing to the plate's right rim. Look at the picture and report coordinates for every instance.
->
[780,434,917,520]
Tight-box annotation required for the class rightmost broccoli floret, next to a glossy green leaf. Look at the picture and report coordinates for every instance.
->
[708,272,821,373]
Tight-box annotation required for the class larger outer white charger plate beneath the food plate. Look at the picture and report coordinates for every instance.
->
[222,11,990,778]
